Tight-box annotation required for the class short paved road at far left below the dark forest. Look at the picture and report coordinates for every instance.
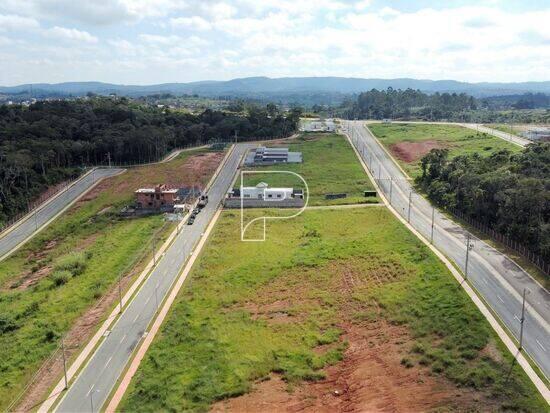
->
[0,169,122,260]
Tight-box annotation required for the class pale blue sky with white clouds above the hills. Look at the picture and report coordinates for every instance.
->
[0,0,550,86]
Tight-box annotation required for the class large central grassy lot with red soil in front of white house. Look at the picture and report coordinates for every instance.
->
[120,208,547,412]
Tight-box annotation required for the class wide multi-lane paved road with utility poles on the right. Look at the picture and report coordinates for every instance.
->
[344,122,550,377]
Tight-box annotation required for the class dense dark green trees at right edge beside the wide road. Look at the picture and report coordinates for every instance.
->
[418,142,550,259]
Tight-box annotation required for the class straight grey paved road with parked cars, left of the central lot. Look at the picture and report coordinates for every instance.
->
[56,144,251,412]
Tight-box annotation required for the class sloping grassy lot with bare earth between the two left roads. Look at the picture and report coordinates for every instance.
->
[0,147,223,410]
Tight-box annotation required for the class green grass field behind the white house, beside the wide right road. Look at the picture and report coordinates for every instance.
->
[244,134,378,205]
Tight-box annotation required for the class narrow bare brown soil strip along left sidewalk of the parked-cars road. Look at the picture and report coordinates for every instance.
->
[15,249,147,412]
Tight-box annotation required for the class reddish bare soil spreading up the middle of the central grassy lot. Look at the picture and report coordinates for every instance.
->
[212,259,498,413]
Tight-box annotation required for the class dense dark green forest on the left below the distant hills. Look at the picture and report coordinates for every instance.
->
[0,98,300,227]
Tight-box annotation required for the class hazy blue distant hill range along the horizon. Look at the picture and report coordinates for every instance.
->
[0,77,550,100]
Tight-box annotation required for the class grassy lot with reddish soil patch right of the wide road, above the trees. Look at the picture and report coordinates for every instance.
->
[369,123,521,178]
